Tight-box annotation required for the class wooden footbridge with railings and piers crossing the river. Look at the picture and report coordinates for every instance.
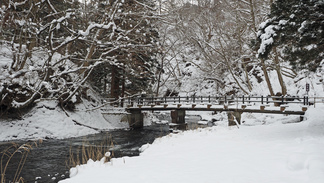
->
[124,96,309,128]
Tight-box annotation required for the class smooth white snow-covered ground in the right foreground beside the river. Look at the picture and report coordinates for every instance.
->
[60,105,324,183]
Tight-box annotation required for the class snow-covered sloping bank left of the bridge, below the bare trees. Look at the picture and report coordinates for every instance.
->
[0,101,128,141]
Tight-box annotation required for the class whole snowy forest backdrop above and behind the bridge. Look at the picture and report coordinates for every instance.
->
[0,0,324,117]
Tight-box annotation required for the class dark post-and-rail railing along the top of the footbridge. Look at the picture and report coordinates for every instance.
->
[124,95,310,106]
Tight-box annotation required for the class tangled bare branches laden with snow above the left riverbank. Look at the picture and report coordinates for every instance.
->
[0,0,159,111]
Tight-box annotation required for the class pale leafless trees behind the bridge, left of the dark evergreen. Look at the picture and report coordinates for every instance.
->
[154,0,274,94]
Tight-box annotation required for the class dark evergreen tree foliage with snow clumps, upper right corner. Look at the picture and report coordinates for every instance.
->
[258,0,324,71]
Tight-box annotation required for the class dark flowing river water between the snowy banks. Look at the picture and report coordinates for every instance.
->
[0,116,199,183]
